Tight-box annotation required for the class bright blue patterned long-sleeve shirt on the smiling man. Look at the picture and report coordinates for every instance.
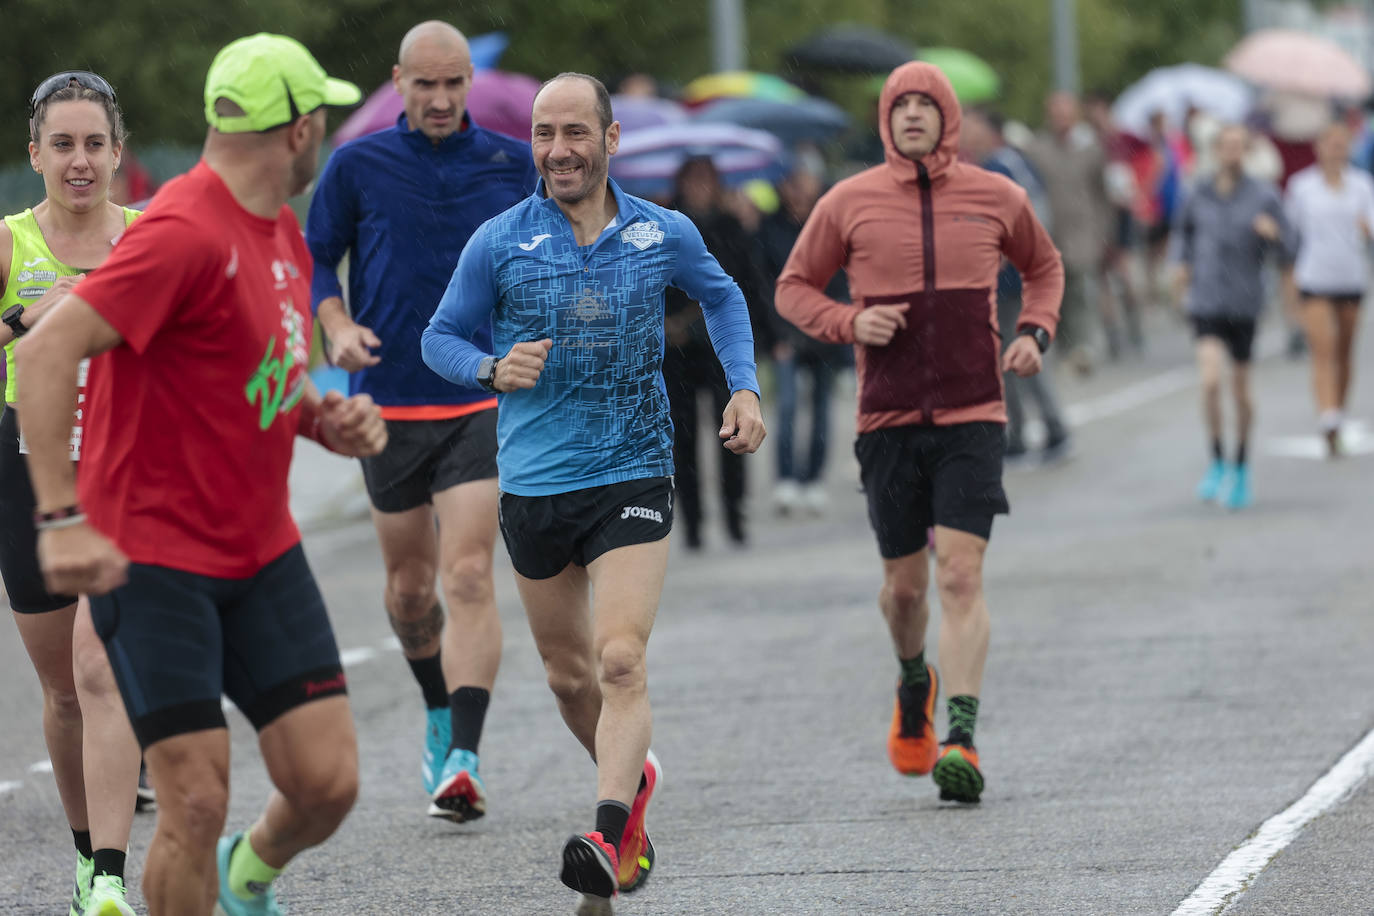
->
[423,181,758,496]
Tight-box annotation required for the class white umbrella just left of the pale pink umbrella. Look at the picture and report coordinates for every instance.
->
[1112,63,1254,137]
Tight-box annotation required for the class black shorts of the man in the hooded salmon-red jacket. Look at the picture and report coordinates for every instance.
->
[855,423,1010,560]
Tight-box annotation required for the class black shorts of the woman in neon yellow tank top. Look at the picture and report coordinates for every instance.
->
[0,405,77,614]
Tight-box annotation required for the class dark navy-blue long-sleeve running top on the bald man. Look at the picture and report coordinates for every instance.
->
[305,115,539,413]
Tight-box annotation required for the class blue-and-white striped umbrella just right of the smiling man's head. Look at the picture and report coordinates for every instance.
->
[610,122,786,196]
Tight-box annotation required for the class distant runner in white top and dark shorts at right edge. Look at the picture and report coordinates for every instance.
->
[1285,122,1374,457]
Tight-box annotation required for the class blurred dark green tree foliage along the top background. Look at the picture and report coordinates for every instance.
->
[0,0,1241,162]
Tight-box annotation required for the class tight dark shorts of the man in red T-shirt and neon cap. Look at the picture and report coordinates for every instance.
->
[91,544,346,747]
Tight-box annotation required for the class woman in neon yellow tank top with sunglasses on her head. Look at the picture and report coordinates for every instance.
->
[0,71,139,916]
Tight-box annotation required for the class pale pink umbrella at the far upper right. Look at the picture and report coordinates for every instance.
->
[1226,29,1370,100]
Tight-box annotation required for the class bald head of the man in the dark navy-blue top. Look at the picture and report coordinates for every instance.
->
[392,19,473,144]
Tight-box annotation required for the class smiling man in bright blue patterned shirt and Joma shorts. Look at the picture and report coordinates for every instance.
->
[423,73,764,912]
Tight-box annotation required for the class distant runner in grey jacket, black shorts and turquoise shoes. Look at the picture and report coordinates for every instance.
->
[1175,125,1285,509]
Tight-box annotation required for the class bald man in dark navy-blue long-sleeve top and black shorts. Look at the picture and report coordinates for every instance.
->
[305,21,539,823]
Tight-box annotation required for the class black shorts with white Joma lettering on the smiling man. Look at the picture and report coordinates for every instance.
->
[500,477,673,580]
